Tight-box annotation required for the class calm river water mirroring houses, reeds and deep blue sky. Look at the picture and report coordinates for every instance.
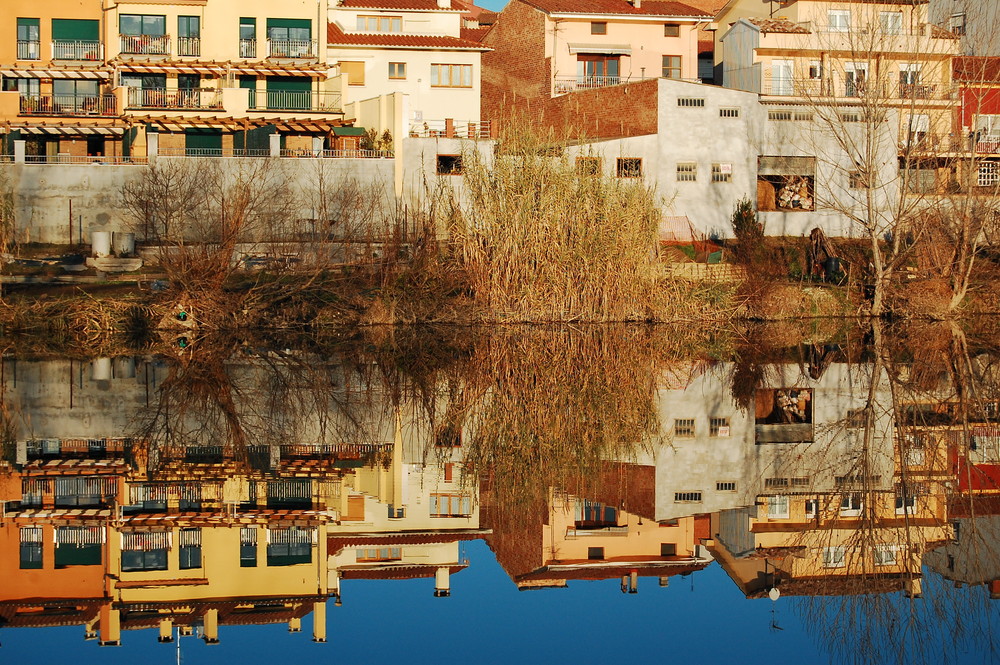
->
[0,322,1000,664]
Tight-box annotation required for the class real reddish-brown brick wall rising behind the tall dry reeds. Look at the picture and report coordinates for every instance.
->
[482,0,657,138]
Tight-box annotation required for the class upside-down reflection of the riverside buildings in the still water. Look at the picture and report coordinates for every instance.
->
[0,330,1000,645]
